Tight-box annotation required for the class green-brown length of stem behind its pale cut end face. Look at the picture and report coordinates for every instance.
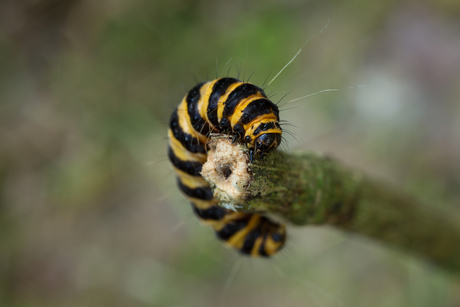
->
[205,138,460,274]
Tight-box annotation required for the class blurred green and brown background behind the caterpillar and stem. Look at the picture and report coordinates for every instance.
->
[0,0,460,307]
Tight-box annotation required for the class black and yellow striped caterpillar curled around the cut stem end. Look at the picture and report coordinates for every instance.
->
[168,78,286,257]
